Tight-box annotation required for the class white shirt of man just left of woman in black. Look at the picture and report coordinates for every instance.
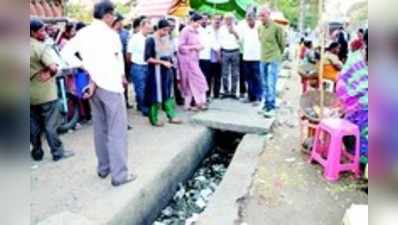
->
[127,32,147,65]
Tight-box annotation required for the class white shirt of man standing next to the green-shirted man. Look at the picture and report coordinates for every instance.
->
[240,23,261,61]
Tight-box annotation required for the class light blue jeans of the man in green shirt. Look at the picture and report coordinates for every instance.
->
[261,62,279,111]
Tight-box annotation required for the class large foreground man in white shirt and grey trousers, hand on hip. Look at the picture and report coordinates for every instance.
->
[62,1,136,186]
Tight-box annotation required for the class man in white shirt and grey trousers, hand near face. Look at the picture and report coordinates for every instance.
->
[219,14,240,99]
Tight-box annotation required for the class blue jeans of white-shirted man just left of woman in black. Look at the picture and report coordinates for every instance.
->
[130,64,149,114]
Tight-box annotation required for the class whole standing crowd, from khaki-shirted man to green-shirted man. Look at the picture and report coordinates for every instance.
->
[30,0,285,186]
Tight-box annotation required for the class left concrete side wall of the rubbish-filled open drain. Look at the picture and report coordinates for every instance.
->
[103,129,214,225]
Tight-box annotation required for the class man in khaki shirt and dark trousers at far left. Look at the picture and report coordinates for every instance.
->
[30,20,73,161]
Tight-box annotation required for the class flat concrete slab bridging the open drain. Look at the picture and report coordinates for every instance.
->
[192,99,274,134]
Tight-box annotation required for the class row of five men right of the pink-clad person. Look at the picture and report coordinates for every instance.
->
[199,8,286,117]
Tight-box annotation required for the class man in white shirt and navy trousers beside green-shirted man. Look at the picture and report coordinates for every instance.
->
[240,12,263,106]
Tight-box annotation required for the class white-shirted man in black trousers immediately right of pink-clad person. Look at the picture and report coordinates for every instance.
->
[198,14,212,98]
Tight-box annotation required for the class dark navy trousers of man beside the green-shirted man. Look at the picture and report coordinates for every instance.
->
[243,61,263,102]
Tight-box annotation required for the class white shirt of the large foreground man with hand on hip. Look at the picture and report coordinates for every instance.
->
[61,20,124,93]
